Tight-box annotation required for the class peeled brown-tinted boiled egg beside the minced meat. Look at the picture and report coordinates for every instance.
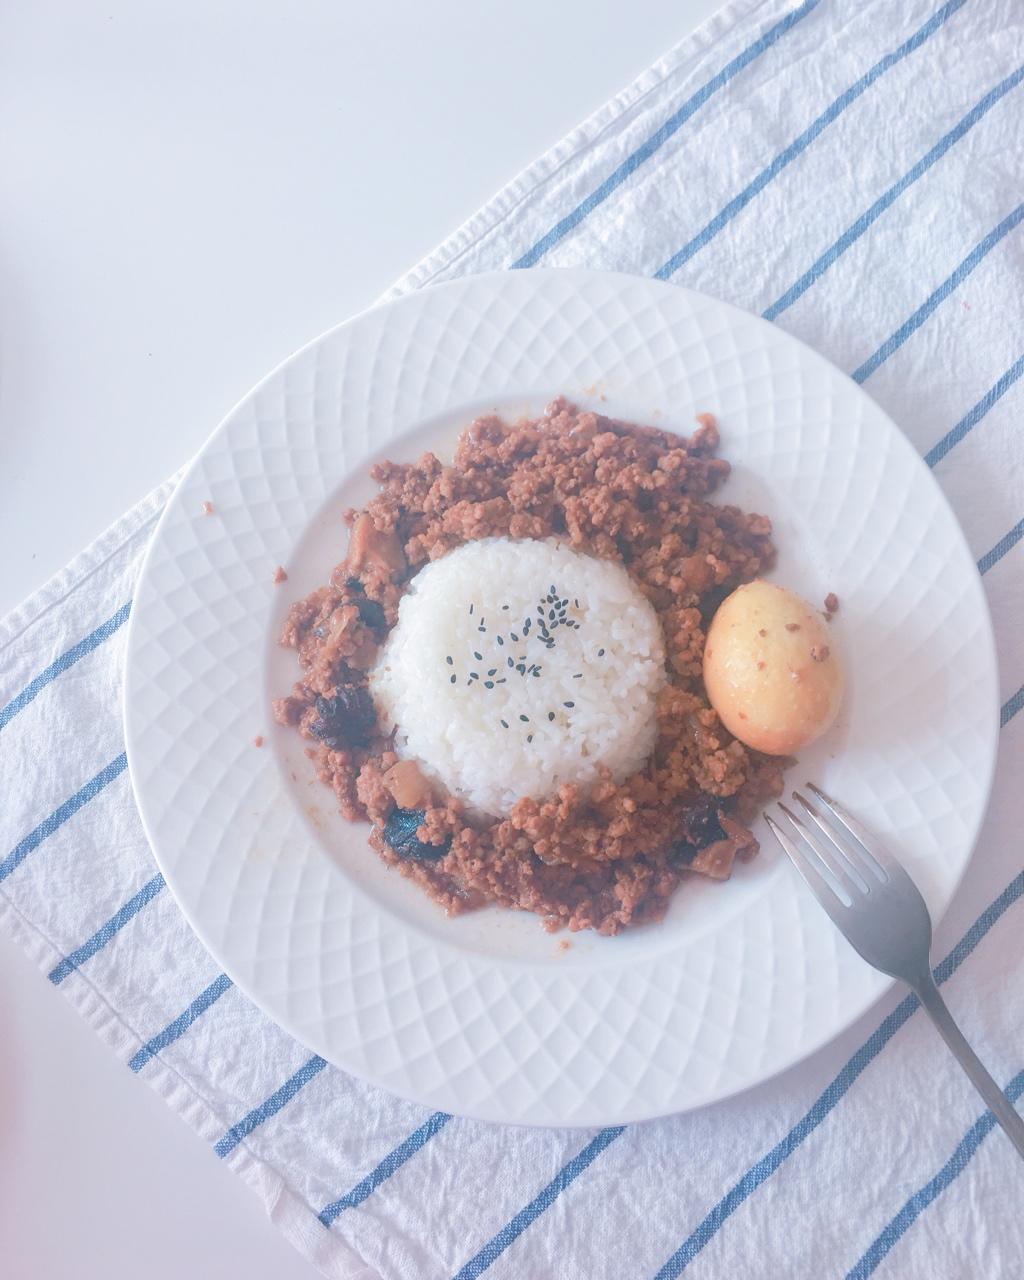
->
[704,581,844,755]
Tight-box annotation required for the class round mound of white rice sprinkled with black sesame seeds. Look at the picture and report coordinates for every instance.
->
[370,538,664,815]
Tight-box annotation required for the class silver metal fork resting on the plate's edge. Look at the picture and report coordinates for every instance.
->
[764,782,1024,1157]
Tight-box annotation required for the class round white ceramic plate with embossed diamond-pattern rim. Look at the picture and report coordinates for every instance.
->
[125,270,997,1125]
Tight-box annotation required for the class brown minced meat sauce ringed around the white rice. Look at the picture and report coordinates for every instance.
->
[275,399,787,933]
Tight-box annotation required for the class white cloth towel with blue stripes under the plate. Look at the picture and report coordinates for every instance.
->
[0,0,1024,1280]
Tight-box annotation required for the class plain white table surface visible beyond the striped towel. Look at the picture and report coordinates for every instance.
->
[0,0,717,1280]
